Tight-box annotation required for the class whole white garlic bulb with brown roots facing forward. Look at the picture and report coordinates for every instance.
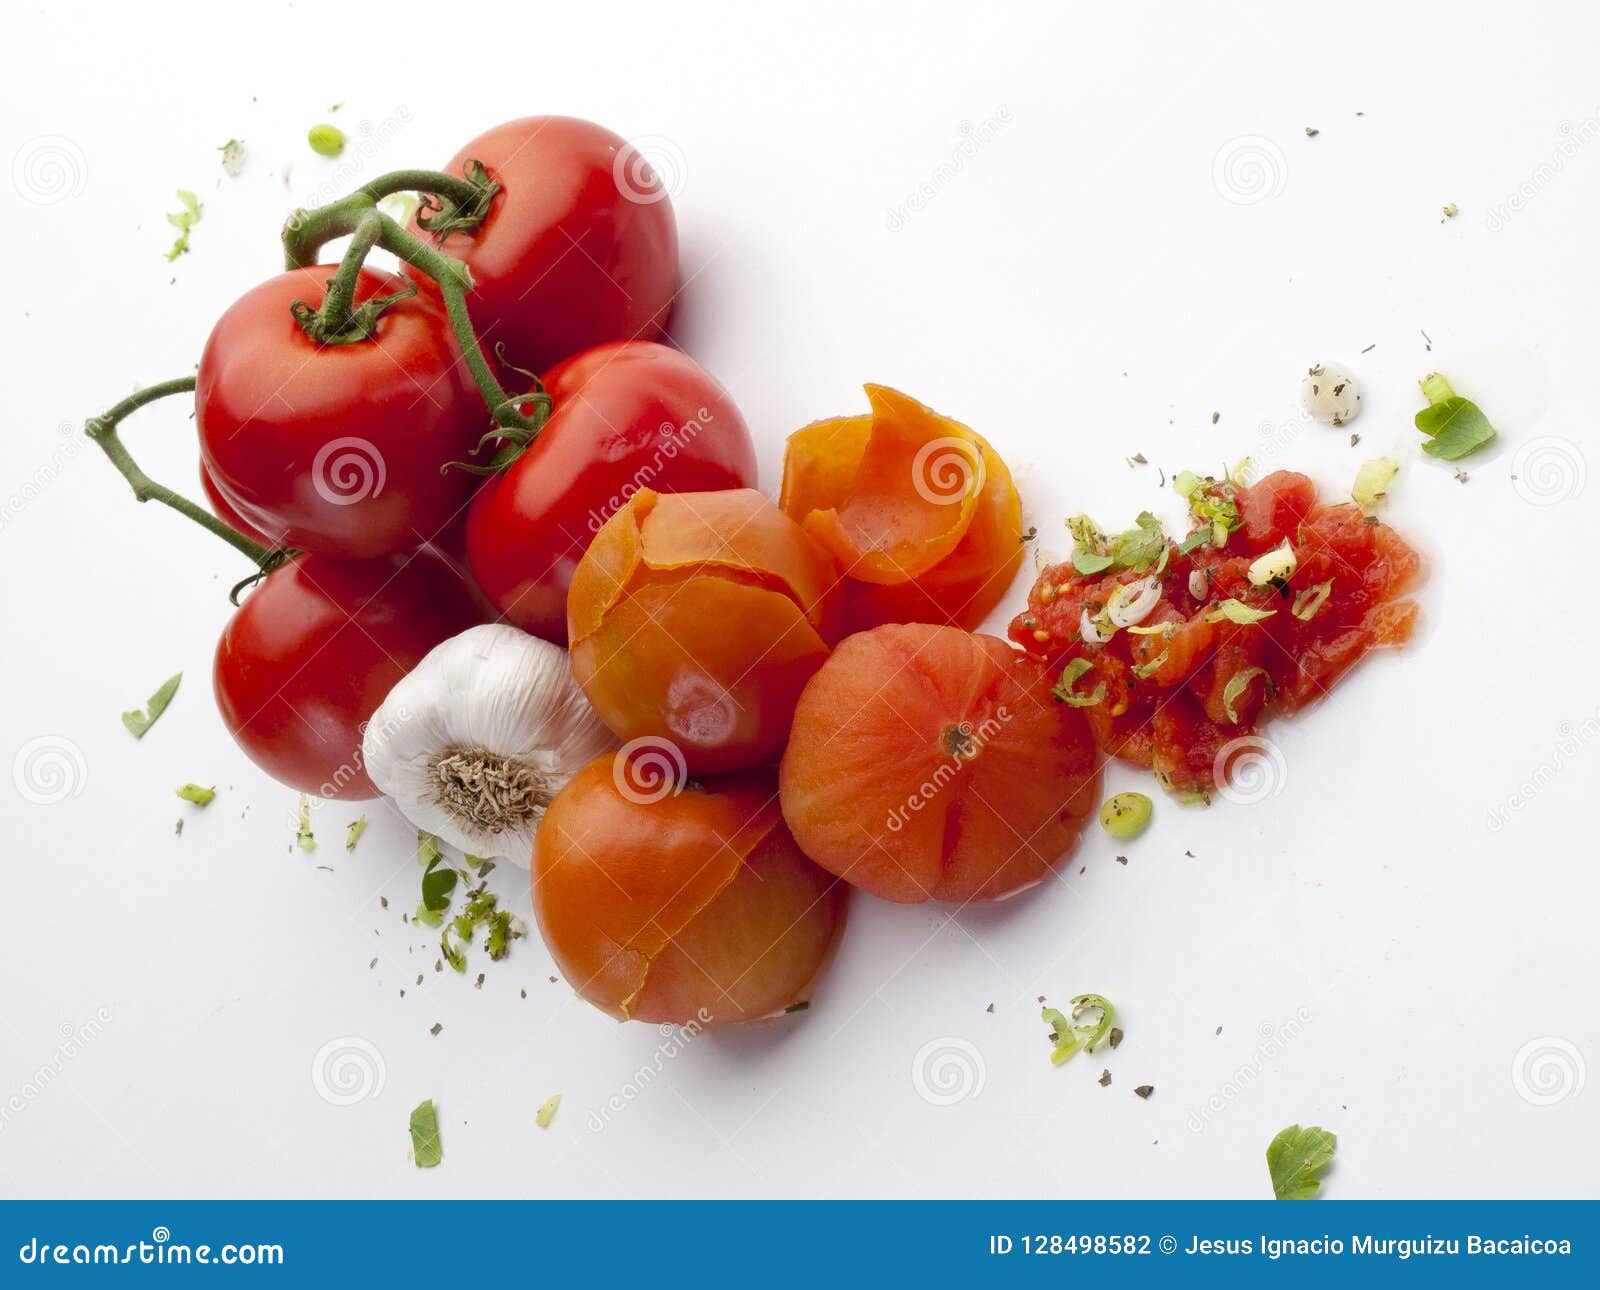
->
[362,623,616,869]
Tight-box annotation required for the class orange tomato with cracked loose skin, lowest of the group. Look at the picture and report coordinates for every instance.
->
[533,754,848,1024]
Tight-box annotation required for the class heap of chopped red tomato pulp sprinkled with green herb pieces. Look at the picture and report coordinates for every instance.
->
[1011,471,1421,797]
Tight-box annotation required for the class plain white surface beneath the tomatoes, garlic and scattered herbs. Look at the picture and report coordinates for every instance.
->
[0,0,1600,1197]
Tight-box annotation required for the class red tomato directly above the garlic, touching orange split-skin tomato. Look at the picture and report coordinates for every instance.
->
[467,341,755,645]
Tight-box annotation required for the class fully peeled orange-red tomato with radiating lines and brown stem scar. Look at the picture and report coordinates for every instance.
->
[778,623,1099,903]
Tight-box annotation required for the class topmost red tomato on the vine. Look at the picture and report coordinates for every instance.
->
[413,117,678,373]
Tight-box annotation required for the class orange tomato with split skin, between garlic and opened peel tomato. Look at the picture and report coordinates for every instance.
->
[566,488,840,775]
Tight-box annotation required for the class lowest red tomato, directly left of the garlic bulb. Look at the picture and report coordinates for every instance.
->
[213,552,483,800]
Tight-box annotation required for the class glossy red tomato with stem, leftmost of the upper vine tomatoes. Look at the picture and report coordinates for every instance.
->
[195,264,490,559]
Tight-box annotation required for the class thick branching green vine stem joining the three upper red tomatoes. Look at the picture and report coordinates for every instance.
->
[283,162,549,448]
